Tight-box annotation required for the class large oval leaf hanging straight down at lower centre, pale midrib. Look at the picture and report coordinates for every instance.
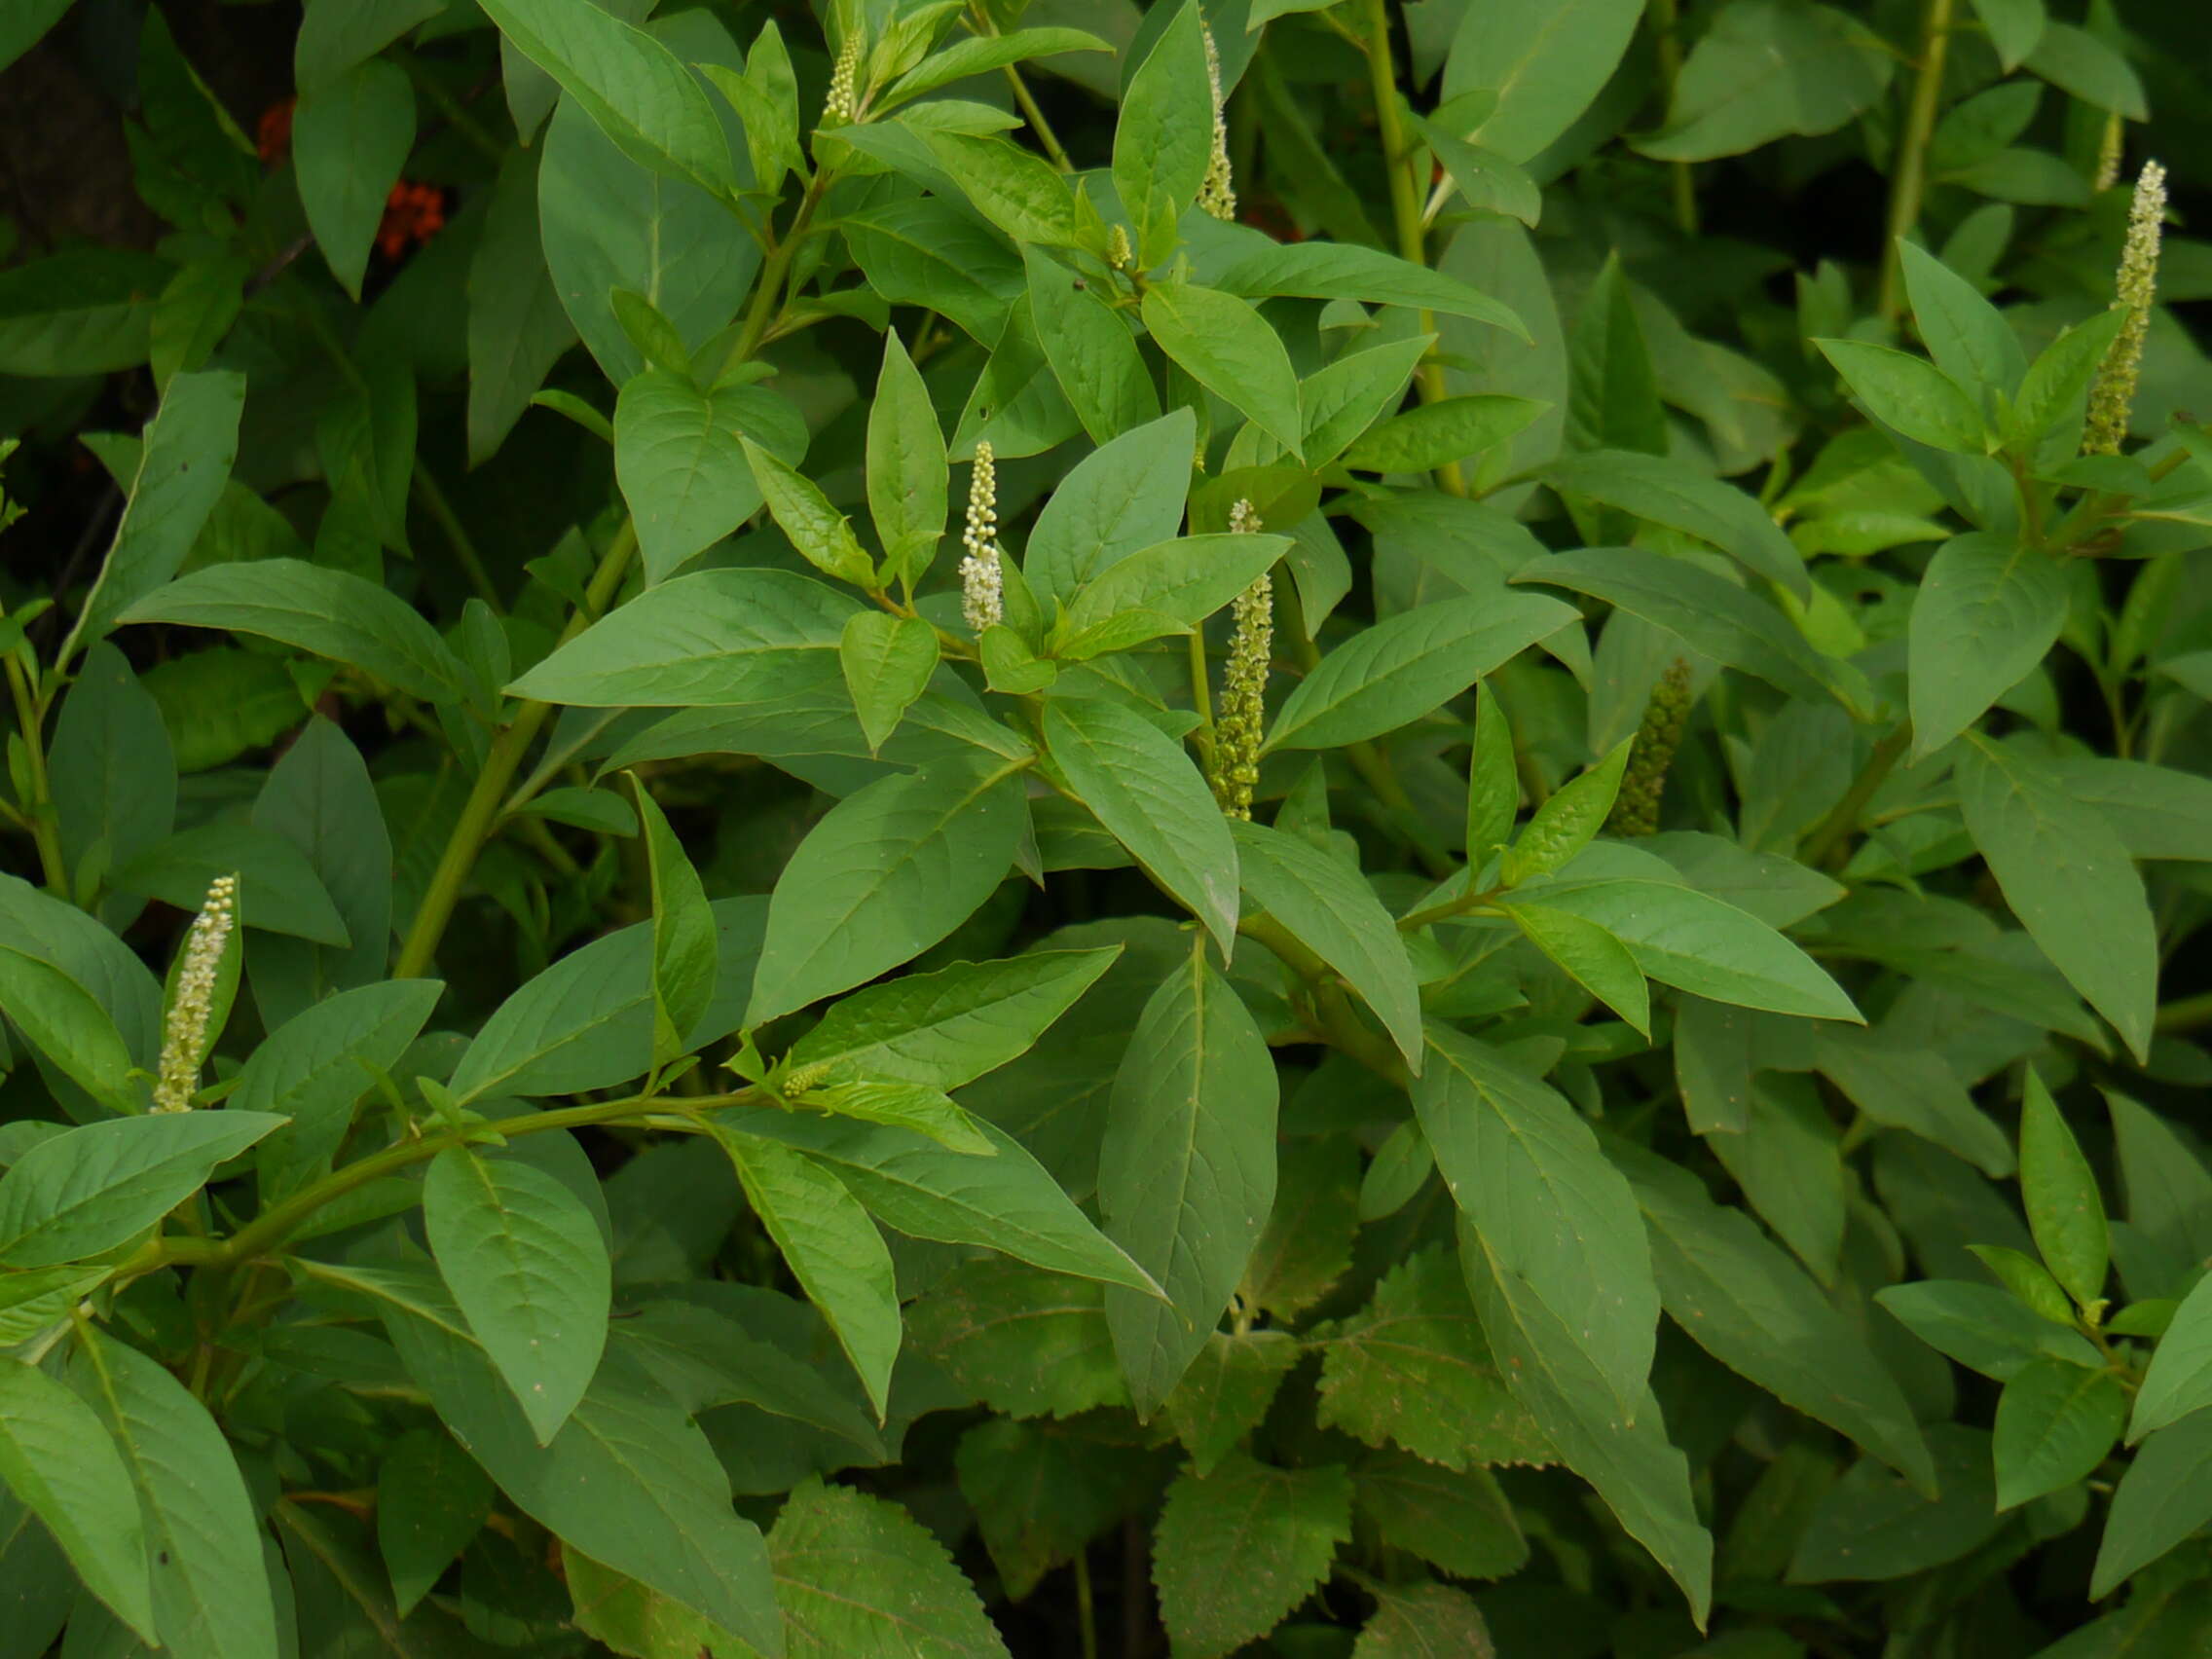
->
[1099,946,1276,1418]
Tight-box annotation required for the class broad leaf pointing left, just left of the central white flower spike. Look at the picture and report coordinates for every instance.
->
[509,569,861,708]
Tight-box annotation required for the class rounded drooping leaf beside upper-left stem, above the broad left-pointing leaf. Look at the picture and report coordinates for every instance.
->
[615,367,807,582]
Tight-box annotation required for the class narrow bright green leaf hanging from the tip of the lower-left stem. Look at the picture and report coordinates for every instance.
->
[708,1120,901,1422]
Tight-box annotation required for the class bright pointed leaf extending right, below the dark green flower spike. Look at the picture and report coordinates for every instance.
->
[1515,873,1862,1024]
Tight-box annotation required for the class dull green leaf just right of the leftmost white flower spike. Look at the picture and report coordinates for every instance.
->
[241,979,445,1201]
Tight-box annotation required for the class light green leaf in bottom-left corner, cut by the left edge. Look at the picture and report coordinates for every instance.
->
[0,1360,160,1641]
